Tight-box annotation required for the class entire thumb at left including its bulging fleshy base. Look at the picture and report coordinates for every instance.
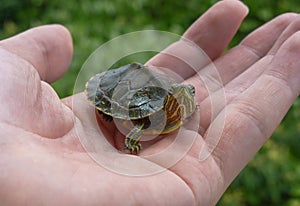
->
[0,25,73,138]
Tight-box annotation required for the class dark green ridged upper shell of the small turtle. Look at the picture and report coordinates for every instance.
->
[85,63,175,120]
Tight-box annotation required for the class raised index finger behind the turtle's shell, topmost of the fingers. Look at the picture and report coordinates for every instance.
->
[147,0,248,79]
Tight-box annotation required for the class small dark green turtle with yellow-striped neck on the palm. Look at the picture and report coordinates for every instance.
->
[85,63,196,153]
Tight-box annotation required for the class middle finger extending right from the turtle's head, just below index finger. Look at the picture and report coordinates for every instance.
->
[187,13,298,102]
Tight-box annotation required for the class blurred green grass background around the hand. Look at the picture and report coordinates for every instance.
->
[0,0,300,206]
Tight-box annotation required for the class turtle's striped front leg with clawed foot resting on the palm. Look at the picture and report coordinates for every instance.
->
[125,123,144,153]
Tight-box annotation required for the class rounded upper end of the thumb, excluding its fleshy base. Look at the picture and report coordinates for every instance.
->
[0,25,73,82]
